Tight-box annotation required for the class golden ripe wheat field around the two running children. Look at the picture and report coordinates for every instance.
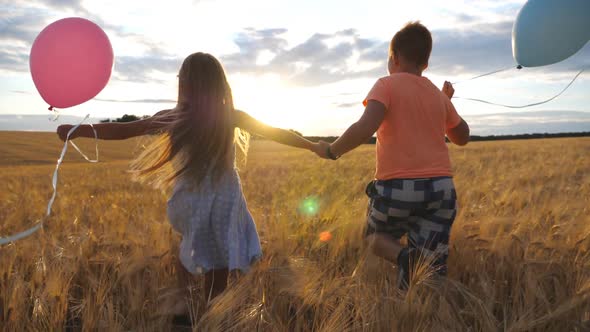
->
[0,132,590,331]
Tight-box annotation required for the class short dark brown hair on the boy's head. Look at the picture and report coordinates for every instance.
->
[389,21,432,66]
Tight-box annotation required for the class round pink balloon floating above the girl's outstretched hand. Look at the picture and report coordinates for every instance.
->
[29,17,114,109]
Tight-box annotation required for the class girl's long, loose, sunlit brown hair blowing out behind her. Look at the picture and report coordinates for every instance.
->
[132,52,249,187]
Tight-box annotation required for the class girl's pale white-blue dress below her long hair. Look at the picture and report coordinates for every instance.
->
[168,169,262,274]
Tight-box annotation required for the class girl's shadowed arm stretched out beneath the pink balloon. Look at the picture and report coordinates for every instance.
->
[57,110,170,141]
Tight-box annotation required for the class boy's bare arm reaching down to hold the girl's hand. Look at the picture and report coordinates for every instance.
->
[322,99,386,157]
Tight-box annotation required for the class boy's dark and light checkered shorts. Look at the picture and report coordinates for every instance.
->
[367,177,457,274]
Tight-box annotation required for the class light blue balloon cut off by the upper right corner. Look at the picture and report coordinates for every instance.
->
[512,0,590,67]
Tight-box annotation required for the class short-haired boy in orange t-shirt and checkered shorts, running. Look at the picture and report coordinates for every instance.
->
[319,22,469,288]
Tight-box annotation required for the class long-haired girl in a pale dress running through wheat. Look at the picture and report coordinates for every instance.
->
[57,53,318,300]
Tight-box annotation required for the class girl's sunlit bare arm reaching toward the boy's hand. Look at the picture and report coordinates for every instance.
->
[235,110,318,152]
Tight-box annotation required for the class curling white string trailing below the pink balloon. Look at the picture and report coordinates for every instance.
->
[0,114,98,245]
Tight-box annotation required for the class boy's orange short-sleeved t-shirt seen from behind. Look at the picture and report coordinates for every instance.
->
[363,73,461,180]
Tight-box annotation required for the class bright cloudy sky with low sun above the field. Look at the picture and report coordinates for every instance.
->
[0,0,590,135]
